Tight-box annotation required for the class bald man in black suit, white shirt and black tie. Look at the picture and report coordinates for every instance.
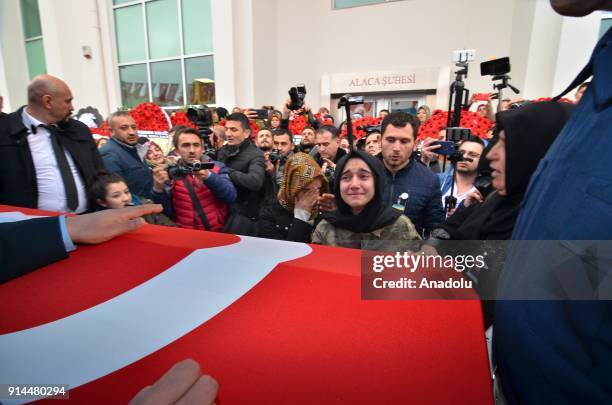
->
[0,74,104,213]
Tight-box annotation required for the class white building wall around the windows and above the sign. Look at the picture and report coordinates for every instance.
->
[0,0,599,114]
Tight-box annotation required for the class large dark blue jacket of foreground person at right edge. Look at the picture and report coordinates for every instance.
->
[493,30,612,404]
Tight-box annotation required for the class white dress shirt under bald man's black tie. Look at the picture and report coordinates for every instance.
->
[21,107,87,213]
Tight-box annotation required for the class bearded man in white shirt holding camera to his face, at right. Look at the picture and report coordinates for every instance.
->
[438,137,484,207]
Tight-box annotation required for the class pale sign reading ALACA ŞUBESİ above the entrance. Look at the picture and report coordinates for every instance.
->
[331,69,439,93]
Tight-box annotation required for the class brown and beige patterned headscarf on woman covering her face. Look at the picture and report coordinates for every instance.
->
[278,152,329,217]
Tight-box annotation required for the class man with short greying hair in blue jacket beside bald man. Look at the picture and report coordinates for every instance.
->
[100,111,153,198]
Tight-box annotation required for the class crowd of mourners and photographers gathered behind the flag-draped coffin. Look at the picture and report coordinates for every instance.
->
[0,70,587,252]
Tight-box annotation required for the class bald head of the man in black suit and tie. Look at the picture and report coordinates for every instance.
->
[28,74,73,124]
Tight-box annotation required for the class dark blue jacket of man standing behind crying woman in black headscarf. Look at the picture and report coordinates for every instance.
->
[384,159,444,235]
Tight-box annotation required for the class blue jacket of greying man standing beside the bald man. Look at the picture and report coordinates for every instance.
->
[100,138,153,198]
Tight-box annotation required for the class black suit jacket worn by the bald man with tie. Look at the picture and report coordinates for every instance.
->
[0,107,104,208]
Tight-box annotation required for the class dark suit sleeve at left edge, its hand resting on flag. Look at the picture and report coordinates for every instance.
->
[0,217,68,283]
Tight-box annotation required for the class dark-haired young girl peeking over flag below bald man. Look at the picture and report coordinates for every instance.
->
[89,172,176,226]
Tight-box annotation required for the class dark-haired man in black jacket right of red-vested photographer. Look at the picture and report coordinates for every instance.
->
[217,113,265,236]
